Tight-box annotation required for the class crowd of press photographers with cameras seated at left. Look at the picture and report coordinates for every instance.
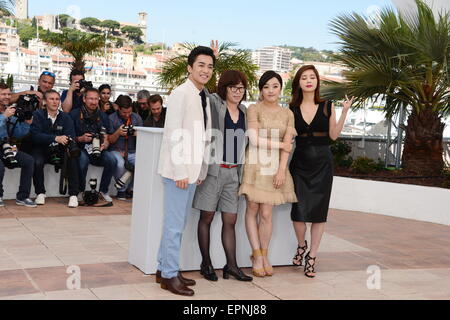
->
[0,70,166,208]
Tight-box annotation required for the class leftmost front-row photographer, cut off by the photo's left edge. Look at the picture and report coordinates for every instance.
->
[0,84,36,208]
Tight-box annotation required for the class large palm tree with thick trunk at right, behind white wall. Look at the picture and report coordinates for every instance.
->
[324,0,450,175]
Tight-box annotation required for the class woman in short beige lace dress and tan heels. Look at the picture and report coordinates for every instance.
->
[239,71,297,277]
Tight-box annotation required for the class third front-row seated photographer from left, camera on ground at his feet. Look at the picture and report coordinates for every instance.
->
[70,88,117,204]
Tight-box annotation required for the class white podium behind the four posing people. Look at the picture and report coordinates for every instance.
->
[129,128,297,274]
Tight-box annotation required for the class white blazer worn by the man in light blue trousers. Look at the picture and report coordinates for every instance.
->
[158,79,211,184]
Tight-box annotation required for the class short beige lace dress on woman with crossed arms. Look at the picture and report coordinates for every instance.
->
[239,103,297,206]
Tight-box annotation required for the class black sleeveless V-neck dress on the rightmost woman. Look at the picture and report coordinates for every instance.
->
[290,101,333,223]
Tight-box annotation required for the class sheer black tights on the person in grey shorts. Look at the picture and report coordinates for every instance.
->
[198,211,237,268]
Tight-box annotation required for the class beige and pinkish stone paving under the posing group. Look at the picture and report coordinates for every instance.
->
[0,199,450,300]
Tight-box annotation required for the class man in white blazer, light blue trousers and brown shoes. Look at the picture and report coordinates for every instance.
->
[156,47,216,296]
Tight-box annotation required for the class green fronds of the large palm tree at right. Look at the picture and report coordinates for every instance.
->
[324,0,450,115]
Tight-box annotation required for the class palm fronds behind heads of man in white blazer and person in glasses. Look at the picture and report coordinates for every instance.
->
[159,42,258,92]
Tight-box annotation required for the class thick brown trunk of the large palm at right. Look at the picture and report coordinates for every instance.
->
[402,107,445,176]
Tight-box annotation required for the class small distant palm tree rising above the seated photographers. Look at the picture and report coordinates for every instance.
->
[42,29,105,71]
